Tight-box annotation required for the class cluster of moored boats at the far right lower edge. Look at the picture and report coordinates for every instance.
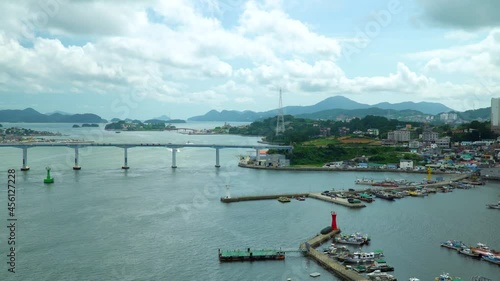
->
[441,240,500,265]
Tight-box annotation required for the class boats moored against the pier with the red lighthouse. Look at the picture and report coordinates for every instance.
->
[324,232,396,281]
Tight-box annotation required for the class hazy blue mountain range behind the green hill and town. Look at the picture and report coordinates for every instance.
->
[188,96,454,122]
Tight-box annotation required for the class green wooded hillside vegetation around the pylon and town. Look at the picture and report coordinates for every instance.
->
[237,116,497,166]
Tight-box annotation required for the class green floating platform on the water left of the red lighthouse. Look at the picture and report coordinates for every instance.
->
[219,248,285,262]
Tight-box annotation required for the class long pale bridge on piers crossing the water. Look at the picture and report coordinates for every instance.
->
[0,142,293,171]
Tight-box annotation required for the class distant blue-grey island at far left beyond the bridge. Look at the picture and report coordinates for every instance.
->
[0,108,108,123]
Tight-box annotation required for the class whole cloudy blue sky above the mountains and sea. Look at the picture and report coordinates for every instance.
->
[0,0,500,120]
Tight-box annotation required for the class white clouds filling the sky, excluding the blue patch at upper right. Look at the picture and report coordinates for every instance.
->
[0,0,500,116]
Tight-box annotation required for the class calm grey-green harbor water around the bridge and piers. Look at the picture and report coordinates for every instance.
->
[0,123,500,281]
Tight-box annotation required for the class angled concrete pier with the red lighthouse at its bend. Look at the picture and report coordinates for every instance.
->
[300,230,370,281]
